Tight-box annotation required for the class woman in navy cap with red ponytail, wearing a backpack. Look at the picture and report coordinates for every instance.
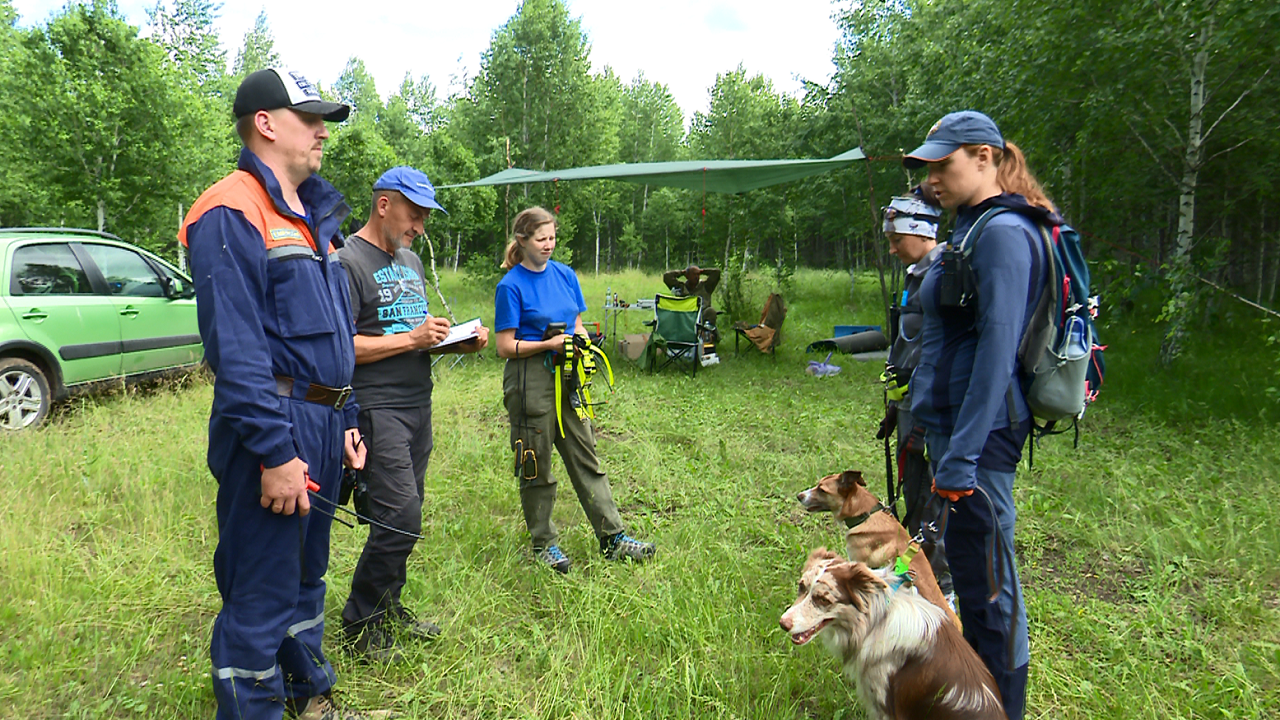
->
[902,110,1062,720]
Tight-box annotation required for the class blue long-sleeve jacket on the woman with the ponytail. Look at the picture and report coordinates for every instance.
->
[911,193,1061,491]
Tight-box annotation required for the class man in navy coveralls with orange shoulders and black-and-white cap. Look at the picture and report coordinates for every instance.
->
[178,68,385,720]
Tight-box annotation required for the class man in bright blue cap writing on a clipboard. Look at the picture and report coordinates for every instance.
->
[338,167,489,662]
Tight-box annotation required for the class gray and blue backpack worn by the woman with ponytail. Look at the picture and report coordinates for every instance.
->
[954,208,1106,437]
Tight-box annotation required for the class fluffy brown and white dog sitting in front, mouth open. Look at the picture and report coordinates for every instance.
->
[778,548,1007,720]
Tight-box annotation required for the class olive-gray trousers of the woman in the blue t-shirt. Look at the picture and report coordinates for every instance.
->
[502,354,623,550]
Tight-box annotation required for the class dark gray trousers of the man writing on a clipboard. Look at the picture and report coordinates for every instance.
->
[342,402,431,632]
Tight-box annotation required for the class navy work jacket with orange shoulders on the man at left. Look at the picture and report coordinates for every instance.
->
[187,149,358,468]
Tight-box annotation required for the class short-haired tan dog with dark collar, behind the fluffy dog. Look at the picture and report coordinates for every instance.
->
[796,470,960,629]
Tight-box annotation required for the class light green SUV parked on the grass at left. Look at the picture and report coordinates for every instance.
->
[0,228,204,430]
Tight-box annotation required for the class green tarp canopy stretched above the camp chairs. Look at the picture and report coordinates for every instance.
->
[440,147,865,192]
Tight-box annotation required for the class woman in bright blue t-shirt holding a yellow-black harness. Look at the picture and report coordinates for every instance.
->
[494,208,654,573]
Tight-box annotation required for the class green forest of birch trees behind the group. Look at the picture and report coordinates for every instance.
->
[0,0,1280,368]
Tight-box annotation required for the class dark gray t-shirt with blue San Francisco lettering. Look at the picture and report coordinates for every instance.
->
[338,236,431,409]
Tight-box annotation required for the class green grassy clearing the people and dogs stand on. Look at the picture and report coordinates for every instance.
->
[0,272,1280,720]
